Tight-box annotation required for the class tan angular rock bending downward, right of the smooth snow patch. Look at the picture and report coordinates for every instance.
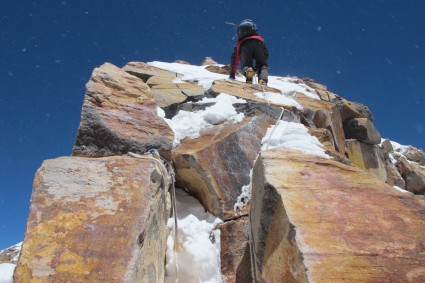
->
[294,93,345,155]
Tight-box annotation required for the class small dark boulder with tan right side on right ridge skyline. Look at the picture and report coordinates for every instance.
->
[344,118,381,145]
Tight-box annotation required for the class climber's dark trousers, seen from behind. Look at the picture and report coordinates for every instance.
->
[239,39,269,81]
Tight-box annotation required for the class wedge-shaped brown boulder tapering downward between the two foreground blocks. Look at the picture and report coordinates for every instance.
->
[172,115,275,220]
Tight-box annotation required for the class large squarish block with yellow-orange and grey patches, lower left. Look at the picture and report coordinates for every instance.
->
[14,156,170,282]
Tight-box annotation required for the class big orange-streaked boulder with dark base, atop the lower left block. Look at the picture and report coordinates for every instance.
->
[72,64,174,158]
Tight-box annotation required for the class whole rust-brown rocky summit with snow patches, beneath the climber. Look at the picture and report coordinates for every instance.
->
[11,57,425,283]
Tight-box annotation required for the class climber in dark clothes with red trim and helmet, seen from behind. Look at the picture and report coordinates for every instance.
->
[229,20,269,85]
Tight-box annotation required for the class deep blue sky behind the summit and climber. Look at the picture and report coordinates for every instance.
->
[0,0,425,249]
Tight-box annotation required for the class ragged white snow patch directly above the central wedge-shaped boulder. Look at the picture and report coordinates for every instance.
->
[157,93,245,147]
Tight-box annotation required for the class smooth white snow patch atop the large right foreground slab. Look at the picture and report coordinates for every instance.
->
[261,121,330,159]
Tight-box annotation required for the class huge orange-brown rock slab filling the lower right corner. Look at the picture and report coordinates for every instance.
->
[251,149,425,282]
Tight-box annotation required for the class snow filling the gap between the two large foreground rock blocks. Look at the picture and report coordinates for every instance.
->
[165,189,222,283]
